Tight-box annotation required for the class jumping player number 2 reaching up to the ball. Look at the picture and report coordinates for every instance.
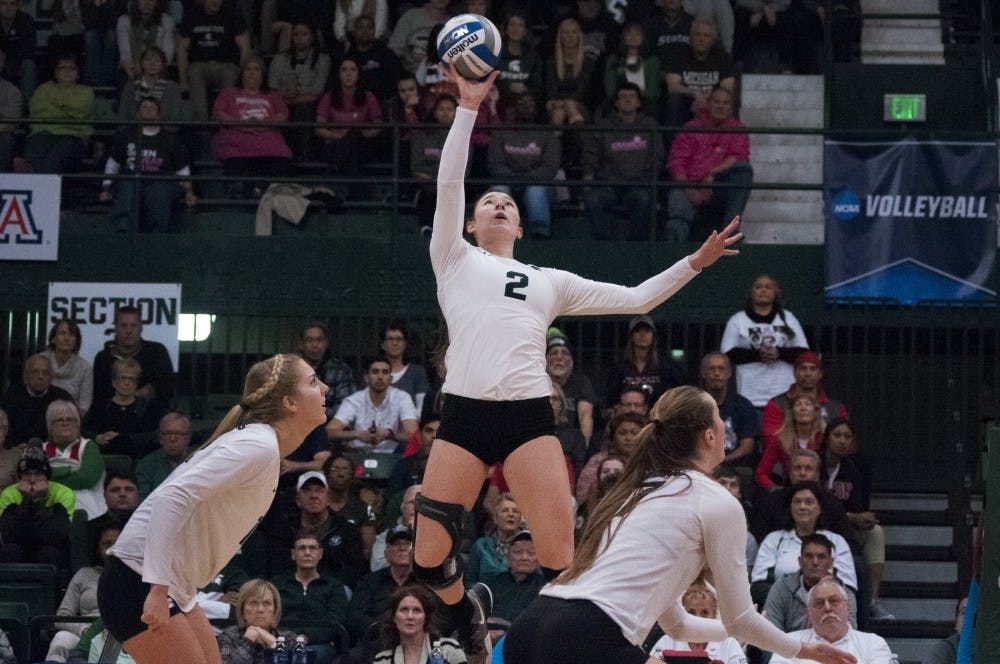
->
[414,67,742,652]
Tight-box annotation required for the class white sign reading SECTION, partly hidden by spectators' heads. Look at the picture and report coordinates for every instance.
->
[45,282,181,371]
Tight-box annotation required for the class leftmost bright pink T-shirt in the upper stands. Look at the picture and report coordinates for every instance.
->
[213,88,292,159]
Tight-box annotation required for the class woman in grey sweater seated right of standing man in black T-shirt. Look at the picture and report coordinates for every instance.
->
[267,21,332,158]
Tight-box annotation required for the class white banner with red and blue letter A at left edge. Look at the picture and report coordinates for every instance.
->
[0,173,62,261]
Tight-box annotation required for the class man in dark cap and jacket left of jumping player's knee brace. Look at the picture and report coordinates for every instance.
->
[347,510,416,662]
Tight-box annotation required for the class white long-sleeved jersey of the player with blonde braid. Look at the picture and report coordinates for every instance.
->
[108,424,281,611]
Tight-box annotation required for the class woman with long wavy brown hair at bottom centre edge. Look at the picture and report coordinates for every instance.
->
[372,588,467,664]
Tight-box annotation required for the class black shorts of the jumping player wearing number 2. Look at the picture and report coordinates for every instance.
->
[437,394,556,466]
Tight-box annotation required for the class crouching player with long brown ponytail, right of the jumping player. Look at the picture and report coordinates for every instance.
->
[504,386,855,664]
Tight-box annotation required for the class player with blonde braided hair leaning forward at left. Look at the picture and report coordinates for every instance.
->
[97,355,328,664]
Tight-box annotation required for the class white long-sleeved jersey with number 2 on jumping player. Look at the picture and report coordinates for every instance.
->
[430,108,697,401]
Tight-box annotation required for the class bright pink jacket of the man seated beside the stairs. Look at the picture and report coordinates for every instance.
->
[667,115,750,180]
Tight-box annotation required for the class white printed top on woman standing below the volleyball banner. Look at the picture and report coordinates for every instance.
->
[719,309,809,408]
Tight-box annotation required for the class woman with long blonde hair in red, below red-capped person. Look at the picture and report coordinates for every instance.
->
[754,394,824,491]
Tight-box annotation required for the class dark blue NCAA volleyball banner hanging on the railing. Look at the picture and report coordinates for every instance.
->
[823,140,997,305]
